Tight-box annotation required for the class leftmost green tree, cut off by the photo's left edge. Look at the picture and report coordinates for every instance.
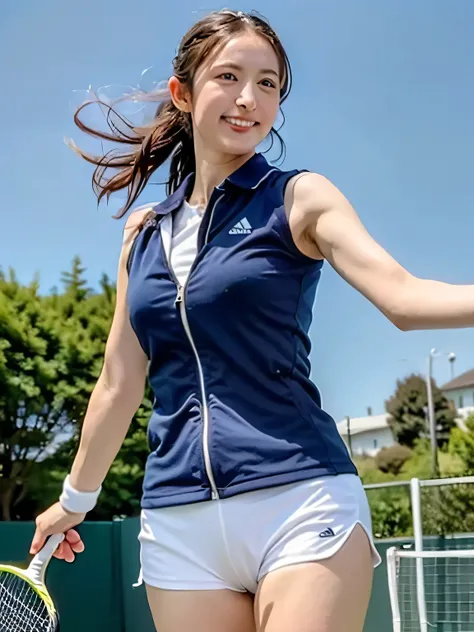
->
[0,272,68,520]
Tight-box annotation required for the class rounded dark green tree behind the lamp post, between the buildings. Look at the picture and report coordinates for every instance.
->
[385,375,456,448]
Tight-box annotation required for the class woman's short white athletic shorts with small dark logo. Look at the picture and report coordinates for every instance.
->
[136,474,381,593]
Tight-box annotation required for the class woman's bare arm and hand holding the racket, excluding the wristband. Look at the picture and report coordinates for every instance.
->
[31,210,148,561]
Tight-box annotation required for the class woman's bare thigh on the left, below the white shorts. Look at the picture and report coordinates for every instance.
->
[146,585,255,632]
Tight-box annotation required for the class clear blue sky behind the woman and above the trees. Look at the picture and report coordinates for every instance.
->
[0,0,474,419]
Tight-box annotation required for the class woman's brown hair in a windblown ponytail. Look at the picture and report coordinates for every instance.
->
[69,9,292,218]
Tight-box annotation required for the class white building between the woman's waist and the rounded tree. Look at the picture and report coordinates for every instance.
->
[337,413,396,456]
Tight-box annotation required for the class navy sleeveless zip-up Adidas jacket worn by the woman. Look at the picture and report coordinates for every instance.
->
[127,154,357,509]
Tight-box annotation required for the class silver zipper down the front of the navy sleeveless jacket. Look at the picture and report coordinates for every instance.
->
[165,194,224,500]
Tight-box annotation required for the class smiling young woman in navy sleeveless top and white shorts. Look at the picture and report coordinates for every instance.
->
[32,10,474,632]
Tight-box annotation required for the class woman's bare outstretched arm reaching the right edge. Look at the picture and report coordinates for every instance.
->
[290,173,474,331]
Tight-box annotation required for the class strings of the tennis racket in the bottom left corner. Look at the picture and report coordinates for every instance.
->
[0,571,54,632]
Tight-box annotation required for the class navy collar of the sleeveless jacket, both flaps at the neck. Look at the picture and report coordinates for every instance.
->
[153,154,279,215]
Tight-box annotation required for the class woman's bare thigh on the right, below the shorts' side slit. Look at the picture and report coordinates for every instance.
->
[255,525,373,632]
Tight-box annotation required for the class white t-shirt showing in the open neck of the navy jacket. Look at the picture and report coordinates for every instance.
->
[161,201,204,285]
